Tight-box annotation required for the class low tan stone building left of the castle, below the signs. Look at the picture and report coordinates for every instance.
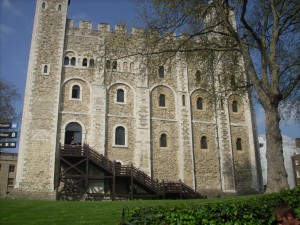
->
[0,152,18,197]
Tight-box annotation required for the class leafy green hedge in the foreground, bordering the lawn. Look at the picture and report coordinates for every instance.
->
[123,187,300,225]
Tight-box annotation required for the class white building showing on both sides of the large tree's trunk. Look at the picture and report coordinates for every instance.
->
[258,135,300,188]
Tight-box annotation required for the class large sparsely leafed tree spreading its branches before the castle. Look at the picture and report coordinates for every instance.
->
[136,0,300,192]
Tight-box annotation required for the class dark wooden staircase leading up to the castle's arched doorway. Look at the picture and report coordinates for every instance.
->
[56,144,203,200]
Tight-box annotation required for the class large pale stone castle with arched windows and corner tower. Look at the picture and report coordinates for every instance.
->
[15,0,260,199]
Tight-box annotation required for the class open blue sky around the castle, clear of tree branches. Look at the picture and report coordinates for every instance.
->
[0,0,300,151]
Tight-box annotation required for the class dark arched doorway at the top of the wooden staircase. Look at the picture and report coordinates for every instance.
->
[65,122,82,145]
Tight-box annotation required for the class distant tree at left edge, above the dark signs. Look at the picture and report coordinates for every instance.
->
[0,80,20,122]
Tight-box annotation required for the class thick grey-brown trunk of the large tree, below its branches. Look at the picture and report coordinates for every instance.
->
[265,104,289,193]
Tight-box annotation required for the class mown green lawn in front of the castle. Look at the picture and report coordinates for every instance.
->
[0,196,260,225]
